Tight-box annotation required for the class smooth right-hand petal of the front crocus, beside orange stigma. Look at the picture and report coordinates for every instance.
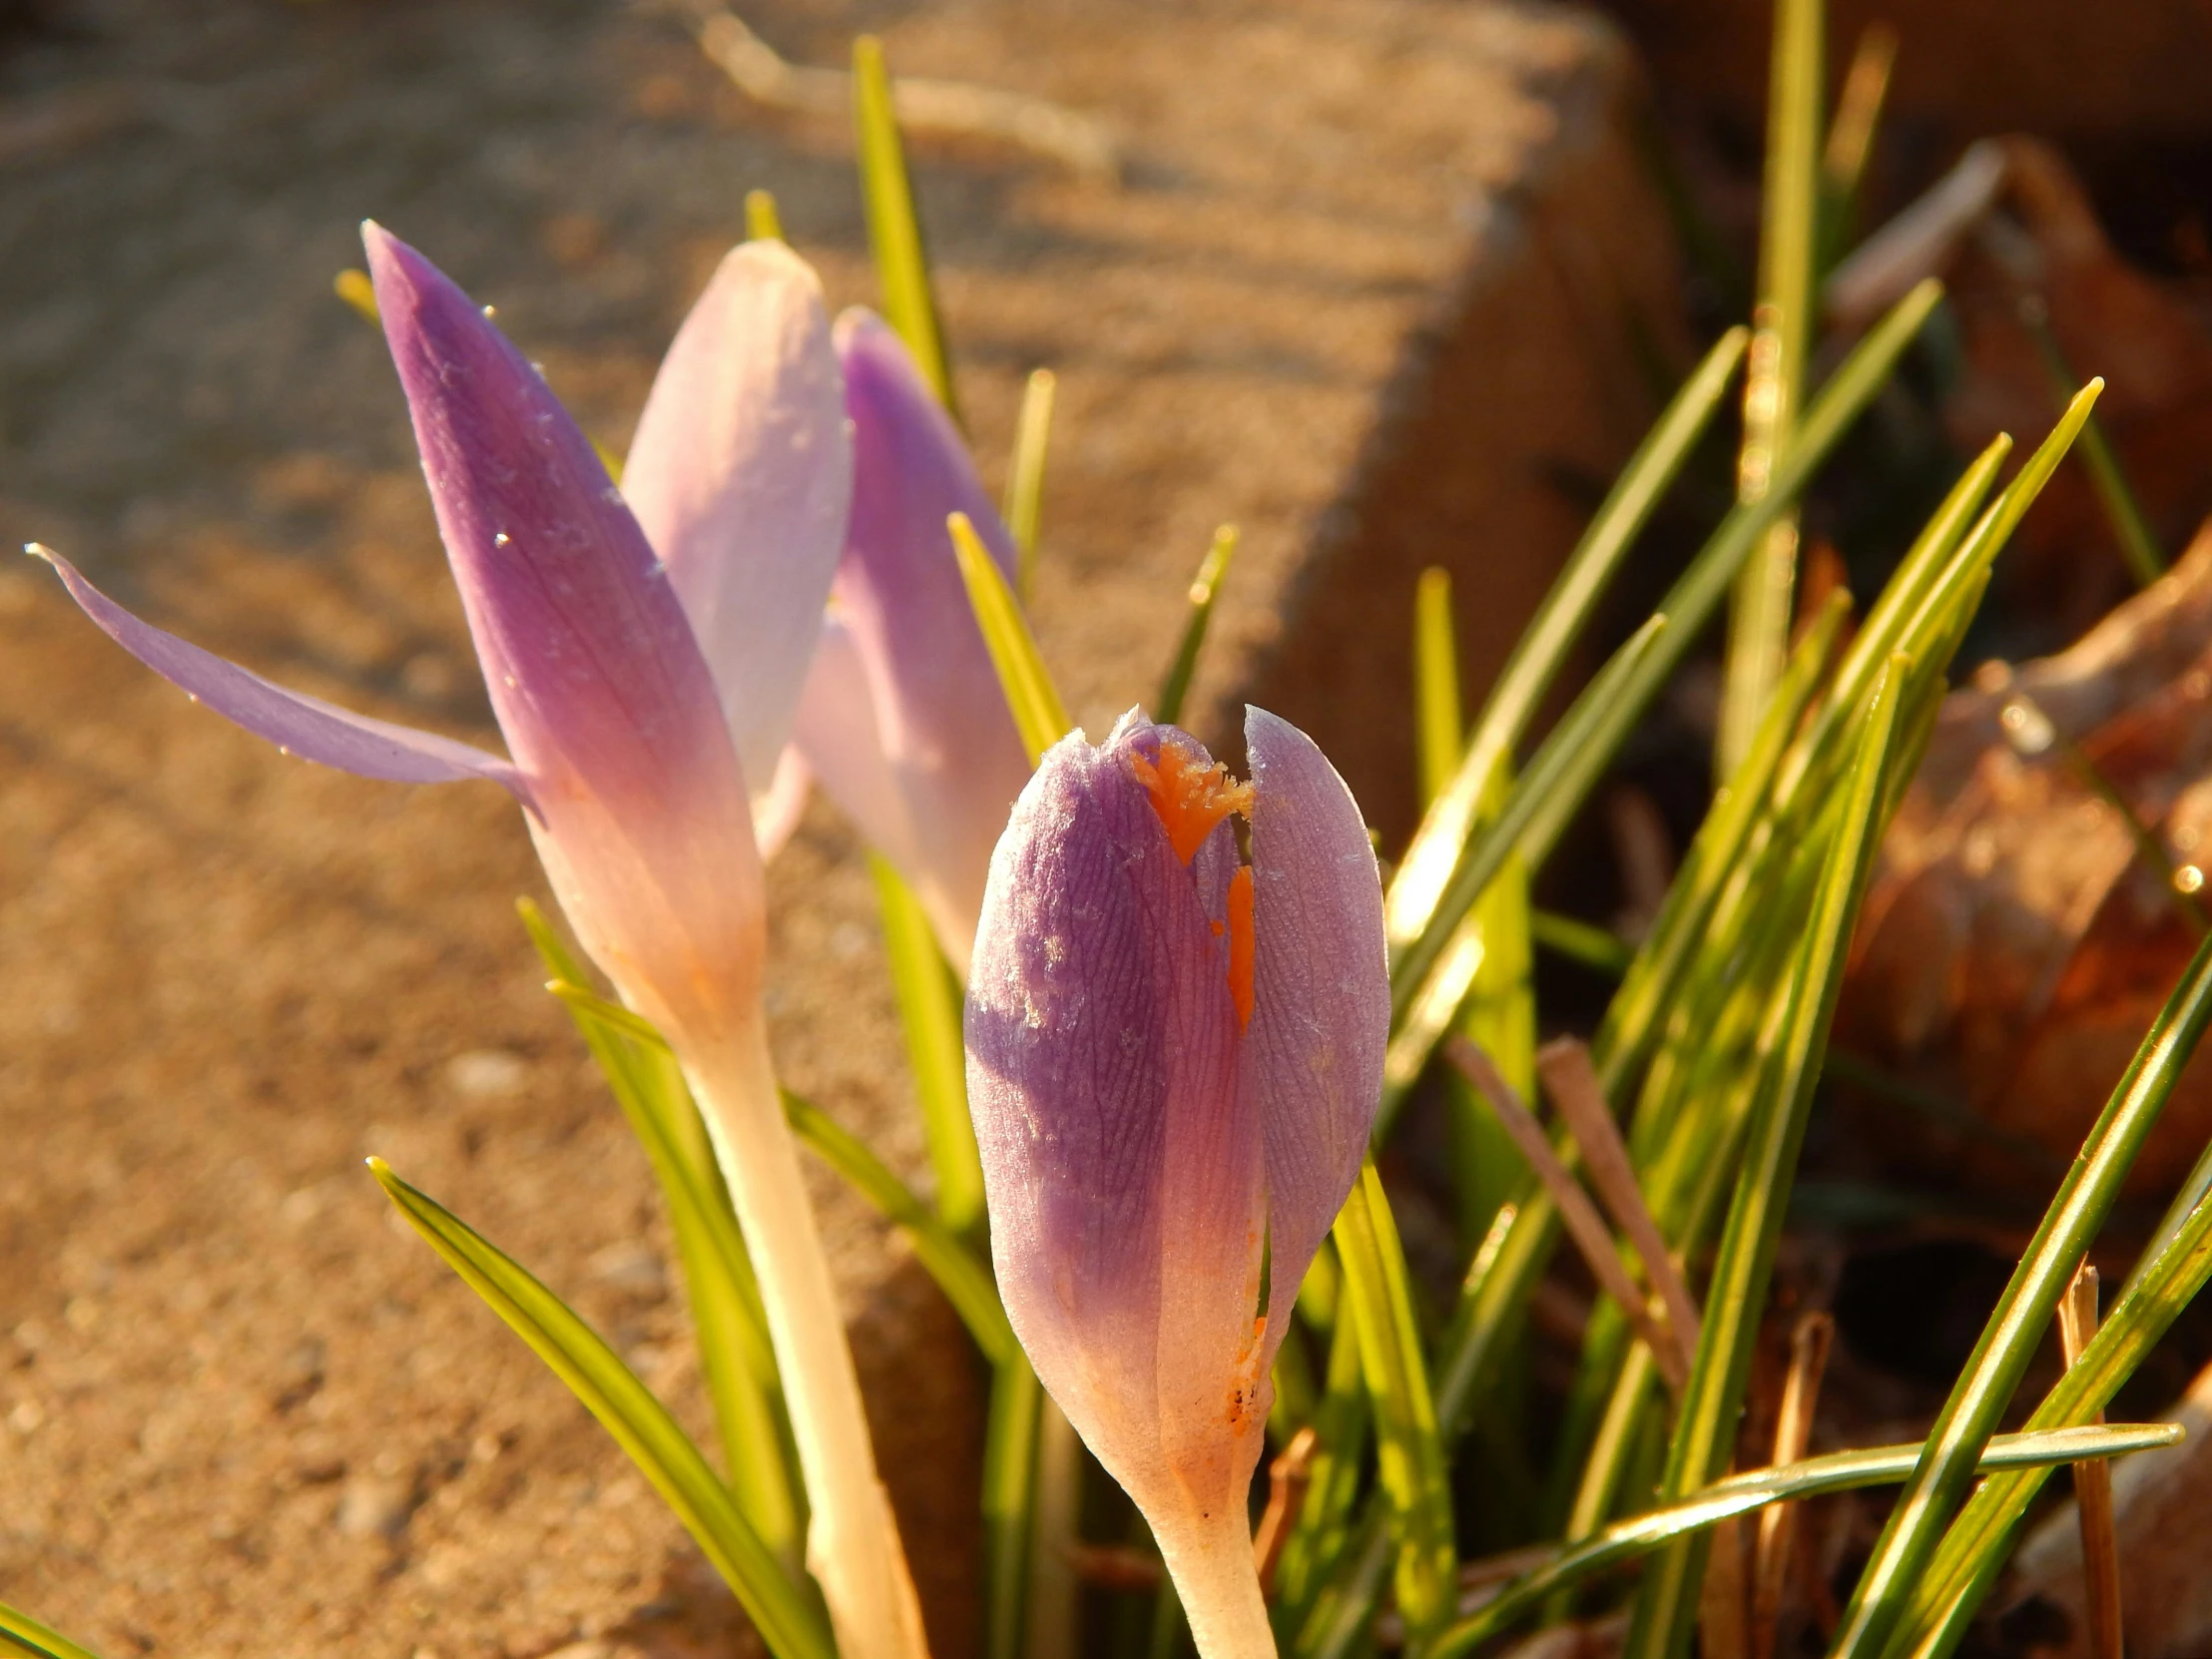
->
[1241,708,1389,1356]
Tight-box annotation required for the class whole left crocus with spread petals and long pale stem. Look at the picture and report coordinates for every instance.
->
[43,226,922,1659]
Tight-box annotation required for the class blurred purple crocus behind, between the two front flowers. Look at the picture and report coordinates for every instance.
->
[797,309,1028,973]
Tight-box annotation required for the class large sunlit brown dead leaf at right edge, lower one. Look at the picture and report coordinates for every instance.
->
[1836,531,2212,1192]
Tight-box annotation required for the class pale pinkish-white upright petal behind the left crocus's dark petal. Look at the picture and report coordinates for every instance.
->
[622,242,851,786]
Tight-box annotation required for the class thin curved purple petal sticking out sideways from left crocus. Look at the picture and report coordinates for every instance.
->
[33,549,531,806]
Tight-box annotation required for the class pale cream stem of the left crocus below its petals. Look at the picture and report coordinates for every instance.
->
[682,1022,929,1659]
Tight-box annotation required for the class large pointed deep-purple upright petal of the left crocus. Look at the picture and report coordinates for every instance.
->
[362,226,766,1026]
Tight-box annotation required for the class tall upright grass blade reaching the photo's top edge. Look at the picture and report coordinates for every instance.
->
[1714,0,1827,783]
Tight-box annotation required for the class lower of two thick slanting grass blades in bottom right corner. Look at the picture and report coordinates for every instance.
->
[1892,1159,2212,1655]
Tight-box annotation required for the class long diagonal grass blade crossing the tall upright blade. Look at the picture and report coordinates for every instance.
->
[1391,280,1942,1013]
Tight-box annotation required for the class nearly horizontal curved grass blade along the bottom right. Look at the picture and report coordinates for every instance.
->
[1422,1422,2181,1659]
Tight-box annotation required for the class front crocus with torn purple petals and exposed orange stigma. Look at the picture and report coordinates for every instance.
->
[966,710,1389,1659]
